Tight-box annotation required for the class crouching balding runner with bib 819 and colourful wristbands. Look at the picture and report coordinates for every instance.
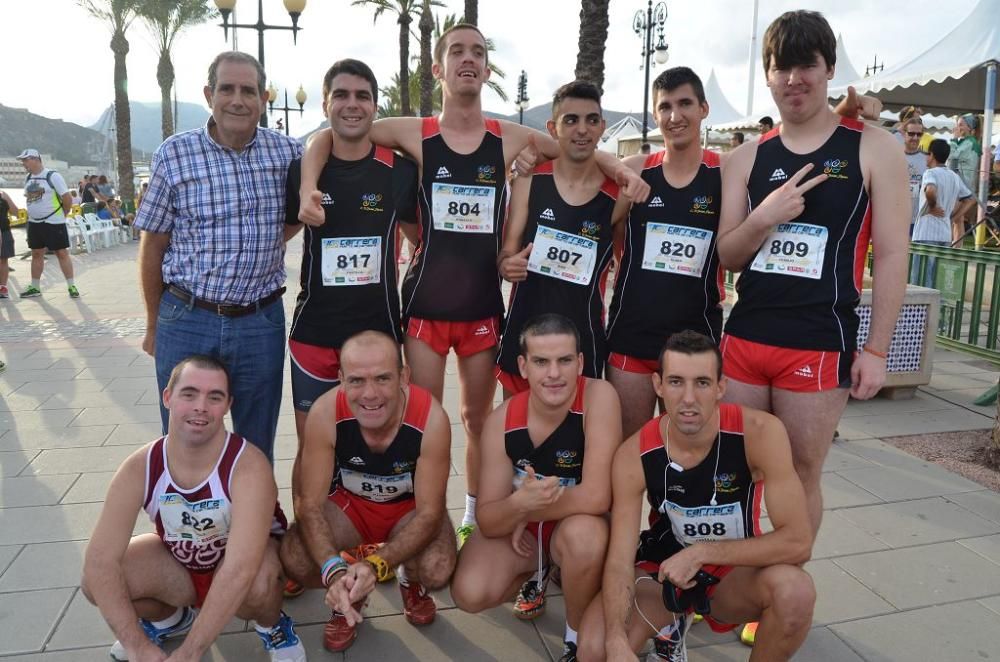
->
[281,331,455,652]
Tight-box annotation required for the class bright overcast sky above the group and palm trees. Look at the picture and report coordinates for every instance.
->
[0,0,980,133]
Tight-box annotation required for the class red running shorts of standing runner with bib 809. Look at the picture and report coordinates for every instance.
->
[719,334,854,393]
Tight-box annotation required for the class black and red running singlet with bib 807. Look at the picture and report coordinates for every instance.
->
[497,161,618,379]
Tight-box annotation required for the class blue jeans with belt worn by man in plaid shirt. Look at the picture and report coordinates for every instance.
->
[155,291,285,461]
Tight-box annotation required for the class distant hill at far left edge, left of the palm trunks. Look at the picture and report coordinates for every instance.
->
[0,104,103,165]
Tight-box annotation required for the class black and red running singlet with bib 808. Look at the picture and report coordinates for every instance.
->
[636,403,764,563]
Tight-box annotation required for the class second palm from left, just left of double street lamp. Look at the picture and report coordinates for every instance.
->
[138,0,215,140]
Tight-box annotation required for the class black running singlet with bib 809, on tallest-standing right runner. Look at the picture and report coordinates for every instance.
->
[726,118,871,352]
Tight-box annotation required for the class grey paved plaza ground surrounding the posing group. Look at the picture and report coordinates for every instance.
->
[0,244,1000,662]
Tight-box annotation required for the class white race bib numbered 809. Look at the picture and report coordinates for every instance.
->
[750,223,830,280]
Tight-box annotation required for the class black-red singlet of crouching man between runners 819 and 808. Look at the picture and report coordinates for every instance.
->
[504,376,587,489]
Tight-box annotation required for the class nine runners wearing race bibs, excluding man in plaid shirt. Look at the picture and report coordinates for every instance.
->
[83,11,909,662]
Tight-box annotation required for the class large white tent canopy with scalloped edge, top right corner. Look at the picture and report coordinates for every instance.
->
[830,0,1000,114]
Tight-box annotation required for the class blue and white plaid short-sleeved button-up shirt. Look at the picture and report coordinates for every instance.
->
[135,119,302,305]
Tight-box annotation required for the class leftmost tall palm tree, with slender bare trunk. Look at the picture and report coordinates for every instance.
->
[77,0,137,206]
